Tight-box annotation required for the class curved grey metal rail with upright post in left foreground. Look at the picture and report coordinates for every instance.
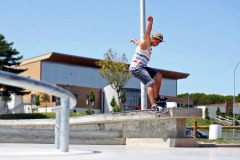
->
[0,70,77,152]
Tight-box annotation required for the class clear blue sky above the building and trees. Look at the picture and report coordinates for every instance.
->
[0,0,240,95]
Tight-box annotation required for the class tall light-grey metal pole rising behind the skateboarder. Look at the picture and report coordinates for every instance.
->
[140,0,147,110]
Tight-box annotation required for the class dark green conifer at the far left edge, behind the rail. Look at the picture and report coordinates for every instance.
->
[0,34,30,102]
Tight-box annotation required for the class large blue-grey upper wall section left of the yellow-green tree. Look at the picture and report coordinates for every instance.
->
[42,62,107,88]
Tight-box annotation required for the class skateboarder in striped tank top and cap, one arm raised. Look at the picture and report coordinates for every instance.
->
[129,16,167,112]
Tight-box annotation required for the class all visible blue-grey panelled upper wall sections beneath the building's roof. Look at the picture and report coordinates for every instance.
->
[42,62,177,96]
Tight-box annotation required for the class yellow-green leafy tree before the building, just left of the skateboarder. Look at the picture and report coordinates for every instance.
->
[96,49,131,107]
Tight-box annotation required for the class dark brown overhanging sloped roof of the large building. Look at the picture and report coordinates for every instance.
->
[21,52,189,79]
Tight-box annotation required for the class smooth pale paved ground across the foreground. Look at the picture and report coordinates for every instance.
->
[0,143,240,160]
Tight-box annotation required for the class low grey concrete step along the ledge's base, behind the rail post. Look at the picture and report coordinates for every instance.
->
[0,128,125,145]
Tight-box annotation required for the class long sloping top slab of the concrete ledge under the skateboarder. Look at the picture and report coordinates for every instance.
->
[0,108,202,126]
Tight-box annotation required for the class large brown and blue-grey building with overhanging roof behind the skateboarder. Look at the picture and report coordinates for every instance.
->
[8,52,193,113]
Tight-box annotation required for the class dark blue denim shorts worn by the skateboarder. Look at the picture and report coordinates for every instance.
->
[130,67,160,86]
